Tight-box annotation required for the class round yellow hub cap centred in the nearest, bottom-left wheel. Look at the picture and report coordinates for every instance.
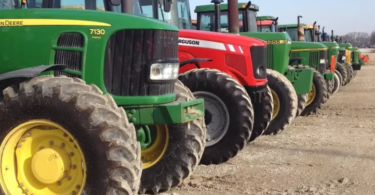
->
[31,148,65,184]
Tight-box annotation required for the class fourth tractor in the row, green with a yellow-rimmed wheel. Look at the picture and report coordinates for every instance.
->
[278,16,334,115]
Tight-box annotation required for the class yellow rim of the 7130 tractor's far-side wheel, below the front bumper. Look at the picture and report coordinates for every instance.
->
[141,125,169,169]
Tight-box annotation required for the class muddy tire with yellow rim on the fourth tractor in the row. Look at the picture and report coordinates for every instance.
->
[301,69,328,116]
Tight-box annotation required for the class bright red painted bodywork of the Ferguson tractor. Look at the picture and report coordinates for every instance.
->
[178,30,267,86]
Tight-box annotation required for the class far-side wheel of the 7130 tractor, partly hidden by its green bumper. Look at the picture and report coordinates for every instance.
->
[138,81,206,193]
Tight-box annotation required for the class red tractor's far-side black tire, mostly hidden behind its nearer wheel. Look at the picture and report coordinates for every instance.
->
[249,86,273,142]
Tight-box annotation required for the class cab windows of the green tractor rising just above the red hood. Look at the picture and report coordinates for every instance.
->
[199,11,244,32]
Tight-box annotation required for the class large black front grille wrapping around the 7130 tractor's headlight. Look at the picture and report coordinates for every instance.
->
[104,30,178,96]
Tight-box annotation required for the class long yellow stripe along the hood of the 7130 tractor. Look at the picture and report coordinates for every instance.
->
[0,19,111,27]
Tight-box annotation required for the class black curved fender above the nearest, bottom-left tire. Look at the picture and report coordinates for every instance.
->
[0,64,66,91]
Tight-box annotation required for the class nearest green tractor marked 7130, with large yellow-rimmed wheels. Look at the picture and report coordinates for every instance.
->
[0,0,206,195]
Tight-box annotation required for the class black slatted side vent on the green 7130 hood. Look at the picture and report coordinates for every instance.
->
[54,33,84,77]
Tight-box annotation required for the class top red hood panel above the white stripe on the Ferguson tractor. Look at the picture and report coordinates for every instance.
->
[178,30,266,47]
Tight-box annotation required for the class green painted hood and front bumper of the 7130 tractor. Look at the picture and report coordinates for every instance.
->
[0,9,204,128]
